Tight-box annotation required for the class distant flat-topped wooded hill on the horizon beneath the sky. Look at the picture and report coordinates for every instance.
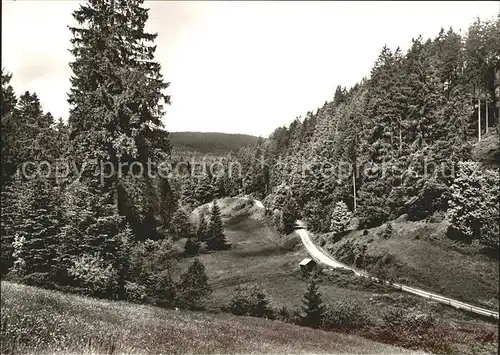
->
[170,132,258,154]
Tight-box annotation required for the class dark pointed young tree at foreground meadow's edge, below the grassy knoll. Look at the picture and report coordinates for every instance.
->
[177,259,212,309]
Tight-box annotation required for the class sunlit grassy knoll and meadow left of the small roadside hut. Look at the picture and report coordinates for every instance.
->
[186,198,388,309]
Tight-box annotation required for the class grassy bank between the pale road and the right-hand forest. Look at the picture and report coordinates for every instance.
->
[320,218,499,309]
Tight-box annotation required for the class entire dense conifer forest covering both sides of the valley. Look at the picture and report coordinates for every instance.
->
[1,0,500,314]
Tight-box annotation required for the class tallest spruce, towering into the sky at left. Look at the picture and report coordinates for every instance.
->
[68,0,170,237]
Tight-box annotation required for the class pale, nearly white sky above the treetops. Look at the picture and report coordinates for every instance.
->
[2,0,500,137]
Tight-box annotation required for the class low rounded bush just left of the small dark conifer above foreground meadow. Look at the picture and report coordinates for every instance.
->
[228,285,276,319]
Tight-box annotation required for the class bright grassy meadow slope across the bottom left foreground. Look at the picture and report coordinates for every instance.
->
[1,282,417,354]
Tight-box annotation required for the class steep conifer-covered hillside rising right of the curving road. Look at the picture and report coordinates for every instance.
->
[237,19,500,256]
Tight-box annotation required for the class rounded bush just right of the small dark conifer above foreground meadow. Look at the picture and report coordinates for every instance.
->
[322,300,371,330]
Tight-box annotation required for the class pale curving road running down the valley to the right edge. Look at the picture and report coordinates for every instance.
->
[295,221,498,319]
